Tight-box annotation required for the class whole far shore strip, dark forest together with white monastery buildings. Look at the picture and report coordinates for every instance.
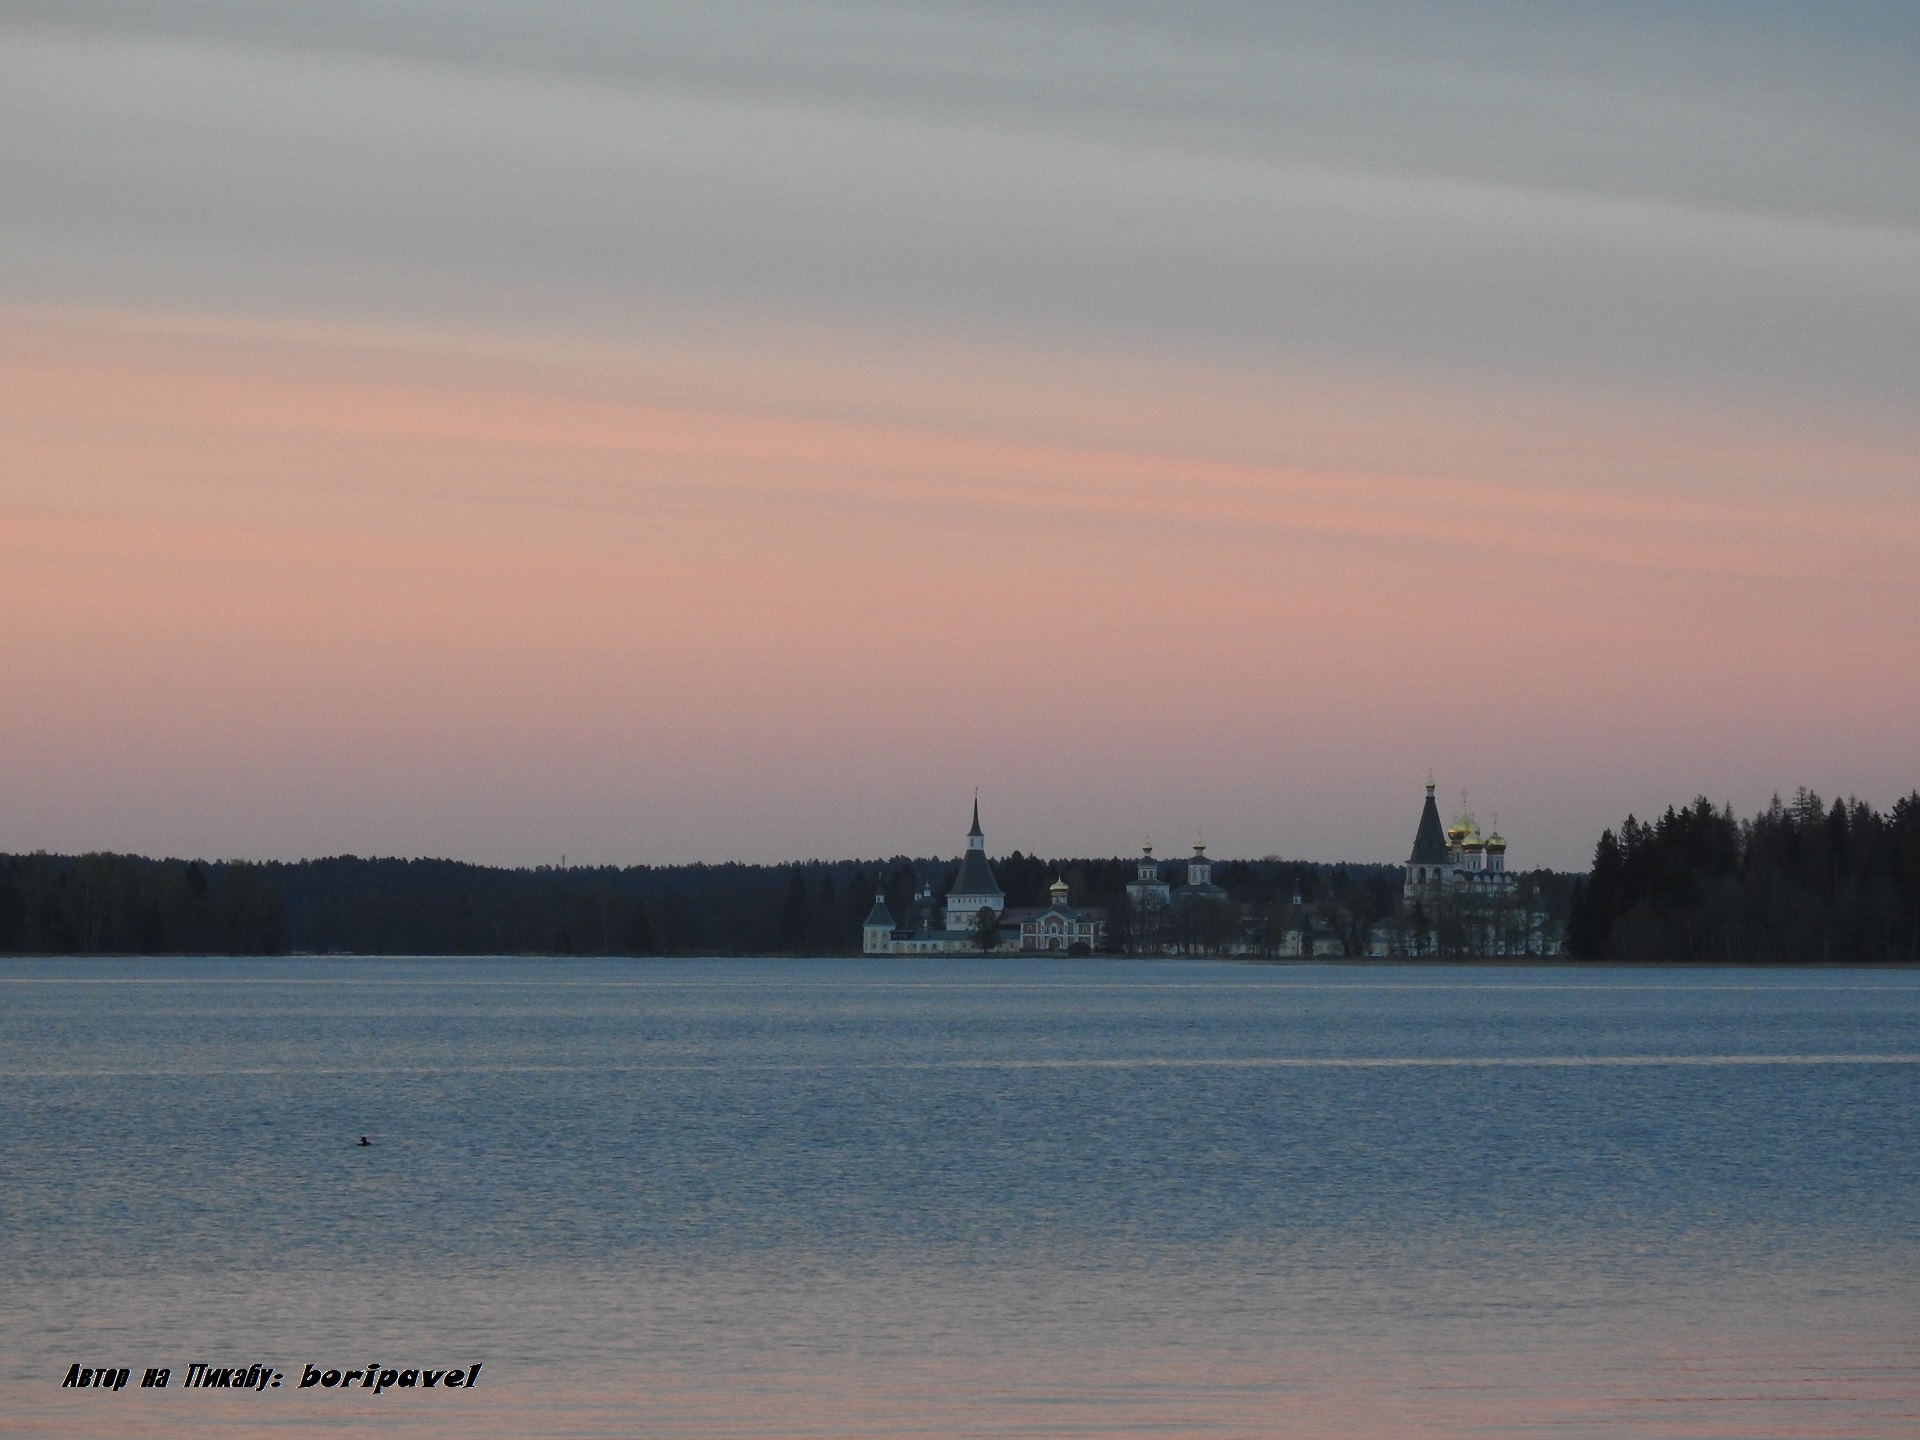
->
[11,785,1920,964]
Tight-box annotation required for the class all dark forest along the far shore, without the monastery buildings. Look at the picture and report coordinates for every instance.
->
[0,791,1920,964]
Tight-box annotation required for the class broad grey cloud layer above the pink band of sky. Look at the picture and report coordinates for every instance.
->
[0,2,1920,414]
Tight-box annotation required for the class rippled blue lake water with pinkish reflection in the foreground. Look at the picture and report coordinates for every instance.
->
[0,960,1920,1440]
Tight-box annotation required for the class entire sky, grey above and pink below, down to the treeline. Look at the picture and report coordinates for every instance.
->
[0,0,1920,868]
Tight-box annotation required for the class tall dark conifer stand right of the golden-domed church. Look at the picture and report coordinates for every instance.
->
[1567,789,1920,964]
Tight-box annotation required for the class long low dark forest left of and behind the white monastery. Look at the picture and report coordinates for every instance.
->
[0,851,1400,956]
